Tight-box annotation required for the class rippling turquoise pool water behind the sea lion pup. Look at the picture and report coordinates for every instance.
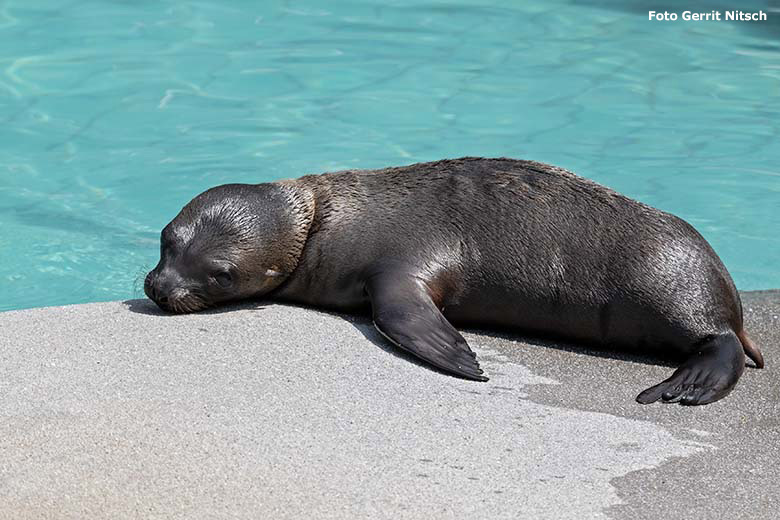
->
[0,0,780,310]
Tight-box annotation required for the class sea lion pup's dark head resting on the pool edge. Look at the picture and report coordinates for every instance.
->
[144,183,314,313]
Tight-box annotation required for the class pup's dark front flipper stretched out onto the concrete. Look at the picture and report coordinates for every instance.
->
[366,272,488,381]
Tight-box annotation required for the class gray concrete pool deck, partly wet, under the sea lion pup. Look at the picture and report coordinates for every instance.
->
[0,291,780,519]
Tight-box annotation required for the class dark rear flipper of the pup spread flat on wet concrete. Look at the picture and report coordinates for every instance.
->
[636,332,745,405]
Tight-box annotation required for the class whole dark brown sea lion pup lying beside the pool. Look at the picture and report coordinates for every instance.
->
[144,157,763,405]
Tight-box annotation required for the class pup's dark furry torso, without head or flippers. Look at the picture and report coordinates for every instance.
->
[274,159,742,349]
